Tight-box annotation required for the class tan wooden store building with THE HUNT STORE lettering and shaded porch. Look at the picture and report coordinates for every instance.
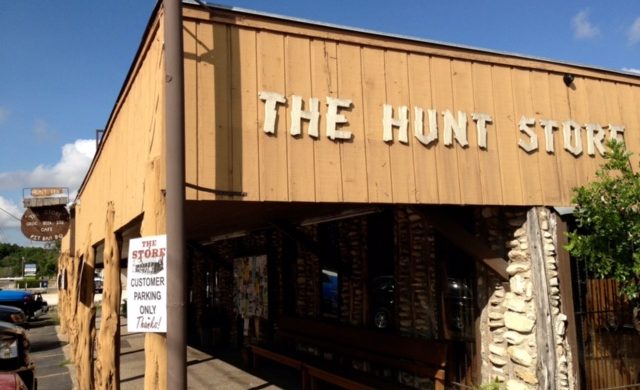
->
[60,2,640,389]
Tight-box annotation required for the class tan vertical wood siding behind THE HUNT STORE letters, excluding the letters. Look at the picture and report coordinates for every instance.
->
[180,10,640,205]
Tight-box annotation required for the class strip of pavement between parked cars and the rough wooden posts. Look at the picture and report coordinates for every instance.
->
[28,314,73,390]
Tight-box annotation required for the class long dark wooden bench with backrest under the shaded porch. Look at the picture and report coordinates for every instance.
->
[250,317,447,390]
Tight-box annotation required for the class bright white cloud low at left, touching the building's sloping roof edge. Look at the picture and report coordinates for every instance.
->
[0,140,96,192]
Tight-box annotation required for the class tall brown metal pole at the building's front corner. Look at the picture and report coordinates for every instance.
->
[164,0,187,390]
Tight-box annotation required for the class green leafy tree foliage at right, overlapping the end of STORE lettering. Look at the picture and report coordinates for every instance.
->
[567,141,640,300]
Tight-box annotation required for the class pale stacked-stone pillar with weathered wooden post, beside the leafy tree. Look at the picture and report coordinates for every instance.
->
[481,208,575,390]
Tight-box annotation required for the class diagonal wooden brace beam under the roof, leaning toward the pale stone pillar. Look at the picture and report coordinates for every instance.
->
[418,208,509,280]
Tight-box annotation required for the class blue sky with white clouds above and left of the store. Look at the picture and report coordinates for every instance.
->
[0,0,640,245]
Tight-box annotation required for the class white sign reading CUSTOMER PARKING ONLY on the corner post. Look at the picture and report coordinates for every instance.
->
[127,235,167,333]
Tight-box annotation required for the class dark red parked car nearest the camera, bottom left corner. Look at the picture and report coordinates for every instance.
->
[0,321,38,390]
